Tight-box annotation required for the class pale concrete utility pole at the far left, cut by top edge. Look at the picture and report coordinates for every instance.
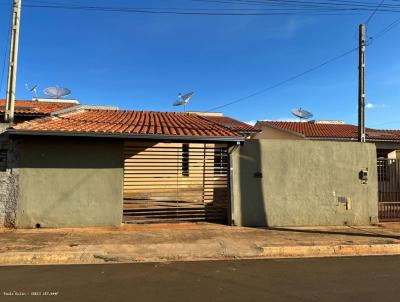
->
[4,0,21,123]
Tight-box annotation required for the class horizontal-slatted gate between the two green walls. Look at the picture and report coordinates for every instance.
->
[124,142,229,223]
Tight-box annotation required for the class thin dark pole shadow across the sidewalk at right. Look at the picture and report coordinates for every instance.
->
[265,226,400,240]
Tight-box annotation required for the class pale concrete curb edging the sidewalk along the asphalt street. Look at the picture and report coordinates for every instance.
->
[0,243,400,266]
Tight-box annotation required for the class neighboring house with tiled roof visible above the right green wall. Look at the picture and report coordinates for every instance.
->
[252,121,400,158]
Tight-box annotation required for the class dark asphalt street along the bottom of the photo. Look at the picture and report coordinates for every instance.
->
[0,256,400,302]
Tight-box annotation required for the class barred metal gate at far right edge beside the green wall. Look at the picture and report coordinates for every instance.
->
[378,159,400,222]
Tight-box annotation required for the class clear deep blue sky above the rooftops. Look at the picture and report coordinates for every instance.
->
[0,0,400,128]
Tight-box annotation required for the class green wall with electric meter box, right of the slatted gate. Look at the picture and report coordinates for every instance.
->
[232,140,378,227]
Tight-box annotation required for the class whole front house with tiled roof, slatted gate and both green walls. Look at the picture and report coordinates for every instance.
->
[0,106,378,228]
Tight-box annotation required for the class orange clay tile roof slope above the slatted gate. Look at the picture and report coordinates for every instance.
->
[14,109,241,137]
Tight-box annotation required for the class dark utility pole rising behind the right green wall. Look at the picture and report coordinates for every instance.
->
[358,24,366,143]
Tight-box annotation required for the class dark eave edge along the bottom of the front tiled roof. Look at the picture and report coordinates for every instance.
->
[7,129,245,142]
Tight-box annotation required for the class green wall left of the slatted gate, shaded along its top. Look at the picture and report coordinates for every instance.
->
[16,138,123,228]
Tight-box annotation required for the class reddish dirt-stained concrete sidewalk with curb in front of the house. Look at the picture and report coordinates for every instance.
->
[0,223,400,265]
